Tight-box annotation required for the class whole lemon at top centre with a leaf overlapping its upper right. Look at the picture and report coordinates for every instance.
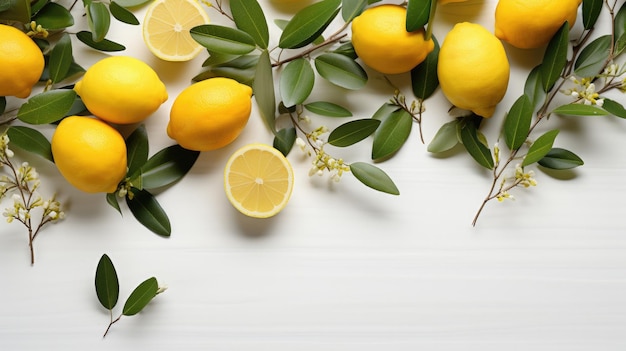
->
[352,4,435,74]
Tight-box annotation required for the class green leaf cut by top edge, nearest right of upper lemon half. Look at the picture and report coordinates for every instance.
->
[230,0,270,49]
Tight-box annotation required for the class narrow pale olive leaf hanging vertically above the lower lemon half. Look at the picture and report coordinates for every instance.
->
[252,50,276,133]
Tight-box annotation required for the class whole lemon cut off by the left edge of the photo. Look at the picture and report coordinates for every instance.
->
[0,24,44,99]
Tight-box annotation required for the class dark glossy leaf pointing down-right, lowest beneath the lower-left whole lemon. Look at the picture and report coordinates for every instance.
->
[126,189,172,237]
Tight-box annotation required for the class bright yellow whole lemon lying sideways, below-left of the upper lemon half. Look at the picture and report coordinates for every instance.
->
[74,56,167,124]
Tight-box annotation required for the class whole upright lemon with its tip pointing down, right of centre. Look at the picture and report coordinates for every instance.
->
[437,22,510,117]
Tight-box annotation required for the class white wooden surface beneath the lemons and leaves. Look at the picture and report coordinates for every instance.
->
[0,0,626,351]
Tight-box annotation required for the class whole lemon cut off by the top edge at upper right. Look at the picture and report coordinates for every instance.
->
[495,0,582,49]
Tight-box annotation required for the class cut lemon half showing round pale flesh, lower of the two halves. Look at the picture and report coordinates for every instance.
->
[224,144,293,218]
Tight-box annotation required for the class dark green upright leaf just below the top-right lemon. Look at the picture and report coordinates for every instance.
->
[541,22,569,92]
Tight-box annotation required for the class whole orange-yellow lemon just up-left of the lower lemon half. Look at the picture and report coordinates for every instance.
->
[167,77,252,151]
